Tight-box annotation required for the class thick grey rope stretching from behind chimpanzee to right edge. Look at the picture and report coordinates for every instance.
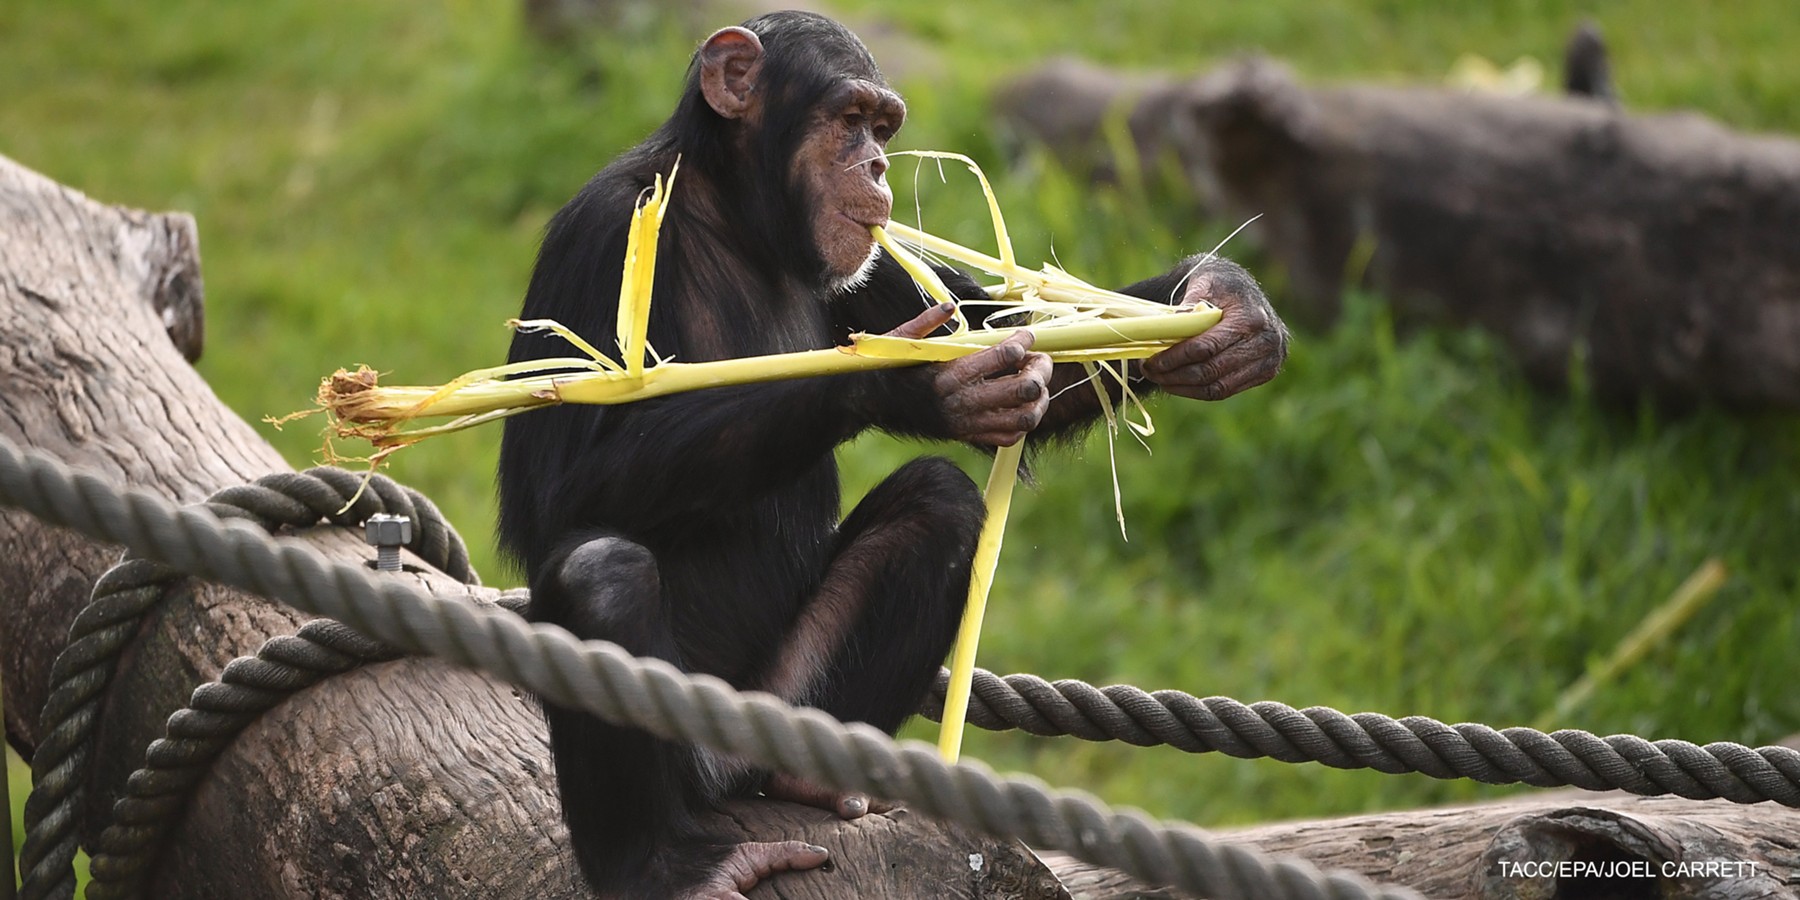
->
[923,670,1800,806]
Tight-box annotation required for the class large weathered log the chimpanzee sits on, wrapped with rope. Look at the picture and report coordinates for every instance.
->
[0,157,1064,900]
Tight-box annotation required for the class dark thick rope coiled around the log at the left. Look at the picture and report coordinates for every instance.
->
[20,466,475,900]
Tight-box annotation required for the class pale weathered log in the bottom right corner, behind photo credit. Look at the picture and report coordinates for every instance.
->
[1044,790,1800,900]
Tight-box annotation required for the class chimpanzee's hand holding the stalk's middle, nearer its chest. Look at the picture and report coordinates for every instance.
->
[889,302,1051,446]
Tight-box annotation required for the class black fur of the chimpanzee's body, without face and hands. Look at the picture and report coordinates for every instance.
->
[499,13,1209,898]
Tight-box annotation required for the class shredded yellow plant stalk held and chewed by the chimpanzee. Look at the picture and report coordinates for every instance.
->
[319,151,1220,761]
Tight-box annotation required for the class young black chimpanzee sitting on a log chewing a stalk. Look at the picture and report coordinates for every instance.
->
[499,13,1287,900]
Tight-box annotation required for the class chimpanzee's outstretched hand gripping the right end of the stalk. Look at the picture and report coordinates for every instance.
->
[1143,259,1287,400]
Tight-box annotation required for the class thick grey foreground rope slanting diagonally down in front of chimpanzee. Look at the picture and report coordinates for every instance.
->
[0,439,1417,900]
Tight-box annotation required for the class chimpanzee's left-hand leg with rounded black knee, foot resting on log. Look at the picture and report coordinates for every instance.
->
[531,533,826,900]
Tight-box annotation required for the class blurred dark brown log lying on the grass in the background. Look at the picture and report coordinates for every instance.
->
[997,59,1800,409]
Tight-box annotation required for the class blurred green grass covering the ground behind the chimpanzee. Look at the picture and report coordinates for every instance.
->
[0,0,1800,871]
